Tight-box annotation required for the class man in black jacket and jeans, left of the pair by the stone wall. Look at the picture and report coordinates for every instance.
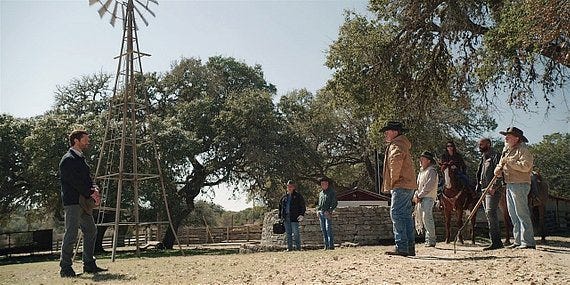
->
[279,180,306,251]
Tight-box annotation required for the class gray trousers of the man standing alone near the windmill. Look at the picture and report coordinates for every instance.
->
[59,205,97,268]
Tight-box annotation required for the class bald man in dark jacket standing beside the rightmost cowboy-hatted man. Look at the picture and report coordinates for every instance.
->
[477,138,504,250]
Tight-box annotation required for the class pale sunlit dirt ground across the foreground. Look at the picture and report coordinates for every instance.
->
[0,237,570,284]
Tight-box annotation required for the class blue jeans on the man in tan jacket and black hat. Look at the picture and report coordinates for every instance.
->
[390,188,416,254]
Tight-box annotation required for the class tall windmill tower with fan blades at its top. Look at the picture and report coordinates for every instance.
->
[89,0,182,261]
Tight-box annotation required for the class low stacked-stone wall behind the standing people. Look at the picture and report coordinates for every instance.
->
[261,203,570,249]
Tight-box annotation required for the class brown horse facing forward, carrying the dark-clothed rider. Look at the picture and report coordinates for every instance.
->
[439,167,477,244]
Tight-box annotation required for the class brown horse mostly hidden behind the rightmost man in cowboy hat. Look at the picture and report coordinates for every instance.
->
[499,171,549,245]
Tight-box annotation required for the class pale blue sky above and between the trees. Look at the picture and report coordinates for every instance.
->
[0,0,570,210]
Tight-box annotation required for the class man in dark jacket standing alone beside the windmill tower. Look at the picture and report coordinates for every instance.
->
[59,130,107,277]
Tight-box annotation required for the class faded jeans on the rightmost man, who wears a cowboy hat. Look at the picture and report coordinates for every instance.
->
[507,183,536,246]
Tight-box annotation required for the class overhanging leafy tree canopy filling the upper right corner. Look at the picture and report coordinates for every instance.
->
[326,0,570,137]
